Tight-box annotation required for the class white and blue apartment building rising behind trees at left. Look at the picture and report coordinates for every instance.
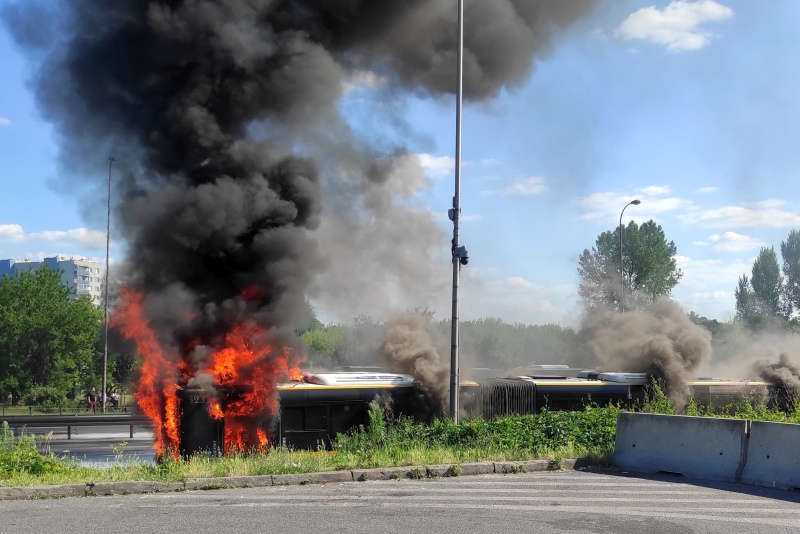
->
[0,256,103,306]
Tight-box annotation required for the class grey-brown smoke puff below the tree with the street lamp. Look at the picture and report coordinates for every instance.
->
[587,300,712,412]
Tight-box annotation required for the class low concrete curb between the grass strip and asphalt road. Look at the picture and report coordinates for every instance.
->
[0,458,589,501]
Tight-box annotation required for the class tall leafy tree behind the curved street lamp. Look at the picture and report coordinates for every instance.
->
[578,220,683,308]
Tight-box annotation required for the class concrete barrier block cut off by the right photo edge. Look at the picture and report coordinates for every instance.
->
[740,421,800,489]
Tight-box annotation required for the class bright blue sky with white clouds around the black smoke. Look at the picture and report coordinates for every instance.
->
[0,0,800,325]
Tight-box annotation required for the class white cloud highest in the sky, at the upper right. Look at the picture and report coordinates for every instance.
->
[616,0,733,52]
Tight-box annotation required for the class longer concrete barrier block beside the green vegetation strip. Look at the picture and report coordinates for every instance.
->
[614,412,748,482]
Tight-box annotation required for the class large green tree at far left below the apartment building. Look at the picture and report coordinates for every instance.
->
[0,267,102,402]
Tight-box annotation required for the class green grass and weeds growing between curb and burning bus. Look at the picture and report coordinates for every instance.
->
[0,396,800,492]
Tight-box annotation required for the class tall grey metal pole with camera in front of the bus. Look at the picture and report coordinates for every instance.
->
[450,0,464,424]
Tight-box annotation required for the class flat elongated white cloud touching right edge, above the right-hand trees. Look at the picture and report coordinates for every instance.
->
[680,199,800,228]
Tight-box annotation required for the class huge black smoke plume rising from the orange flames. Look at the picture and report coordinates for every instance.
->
[3,0,594,374]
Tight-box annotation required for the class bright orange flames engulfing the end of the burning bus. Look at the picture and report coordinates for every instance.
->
[110,287,304,458]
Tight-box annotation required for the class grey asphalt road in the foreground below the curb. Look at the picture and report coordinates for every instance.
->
[0,471,800,534]
